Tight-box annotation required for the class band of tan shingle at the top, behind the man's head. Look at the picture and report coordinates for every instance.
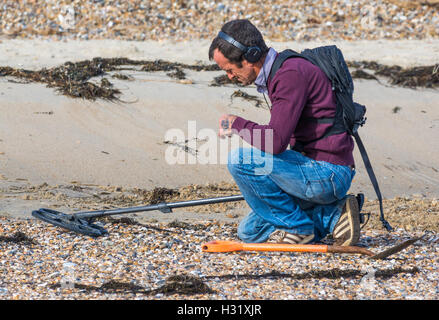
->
[0,0,439,41]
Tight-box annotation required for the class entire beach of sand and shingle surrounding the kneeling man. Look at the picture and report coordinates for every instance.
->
[0,0,439,300]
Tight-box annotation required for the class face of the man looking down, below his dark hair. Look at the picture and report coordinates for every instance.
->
[213,49,257,86]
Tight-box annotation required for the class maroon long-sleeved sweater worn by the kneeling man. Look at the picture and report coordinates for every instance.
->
[232,58,354,165]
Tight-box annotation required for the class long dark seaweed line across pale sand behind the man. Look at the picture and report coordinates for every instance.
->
[0,57,439,102]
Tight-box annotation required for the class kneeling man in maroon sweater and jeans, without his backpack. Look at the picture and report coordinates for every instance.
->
[209,20,360,245]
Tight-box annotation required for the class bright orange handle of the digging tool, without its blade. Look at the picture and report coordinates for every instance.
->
[201,240,328,253]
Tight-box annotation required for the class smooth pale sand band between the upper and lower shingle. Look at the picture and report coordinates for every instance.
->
[0,40,439,199]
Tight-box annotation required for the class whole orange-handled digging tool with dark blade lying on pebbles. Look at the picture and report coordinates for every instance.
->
[201,237,421,259]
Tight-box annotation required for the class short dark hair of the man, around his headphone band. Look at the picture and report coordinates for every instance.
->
[209,19,269,67]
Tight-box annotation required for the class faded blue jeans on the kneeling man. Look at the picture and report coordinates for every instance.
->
[228,148,355,242]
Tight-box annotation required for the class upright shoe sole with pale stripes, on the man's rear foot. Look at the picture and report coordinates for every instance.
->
[332,194,360,246]
